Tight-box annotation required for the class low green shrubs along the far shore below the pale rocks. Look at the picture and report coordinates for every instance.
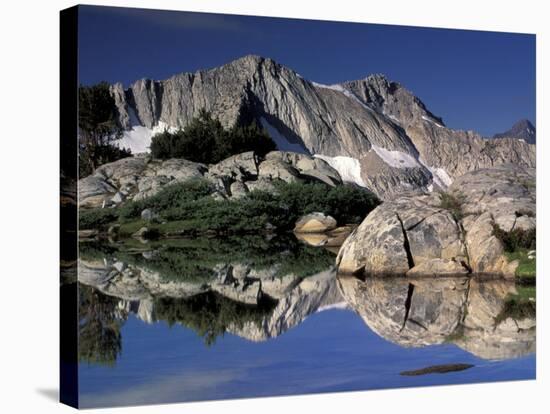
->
[80,179,379,234]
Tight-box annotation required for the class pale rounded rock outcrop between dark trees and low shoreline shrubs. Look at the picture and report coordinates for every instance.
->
[78,151,342,208]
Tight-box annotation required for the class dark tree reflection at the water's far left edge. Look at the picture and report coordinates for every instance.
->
[78,284,123,366]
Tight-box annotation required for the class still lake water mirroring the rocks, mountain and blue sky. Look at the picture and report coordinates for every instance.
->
[75,237,536,407]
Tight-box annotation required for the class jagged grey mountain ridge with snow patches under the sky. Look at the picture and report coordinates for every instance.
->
[112,56,535,198]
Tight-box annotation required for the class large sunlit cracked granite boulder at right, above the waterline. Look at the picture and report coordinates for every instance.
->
[337,165,536,276]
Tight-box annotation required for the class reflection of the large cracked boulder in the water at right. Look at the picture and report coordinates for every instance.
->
[337,275,536,359]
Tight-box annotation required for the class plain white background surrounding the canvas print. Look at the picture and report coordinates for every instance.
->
[0,0,550,414]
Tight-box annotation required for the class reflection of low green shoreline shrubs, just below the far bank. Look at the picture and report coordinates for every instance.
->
[80,236,334,283]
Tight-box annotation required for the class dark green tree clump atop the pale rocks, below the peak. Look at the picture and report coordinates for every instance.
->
[151,110,276,164]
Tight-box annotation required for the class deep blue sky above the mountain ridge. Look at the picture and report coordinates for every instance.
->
[79,6,536,136]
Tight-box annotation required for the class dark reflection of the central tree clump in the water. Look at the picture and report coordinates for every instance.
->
[154,292,276,345]
